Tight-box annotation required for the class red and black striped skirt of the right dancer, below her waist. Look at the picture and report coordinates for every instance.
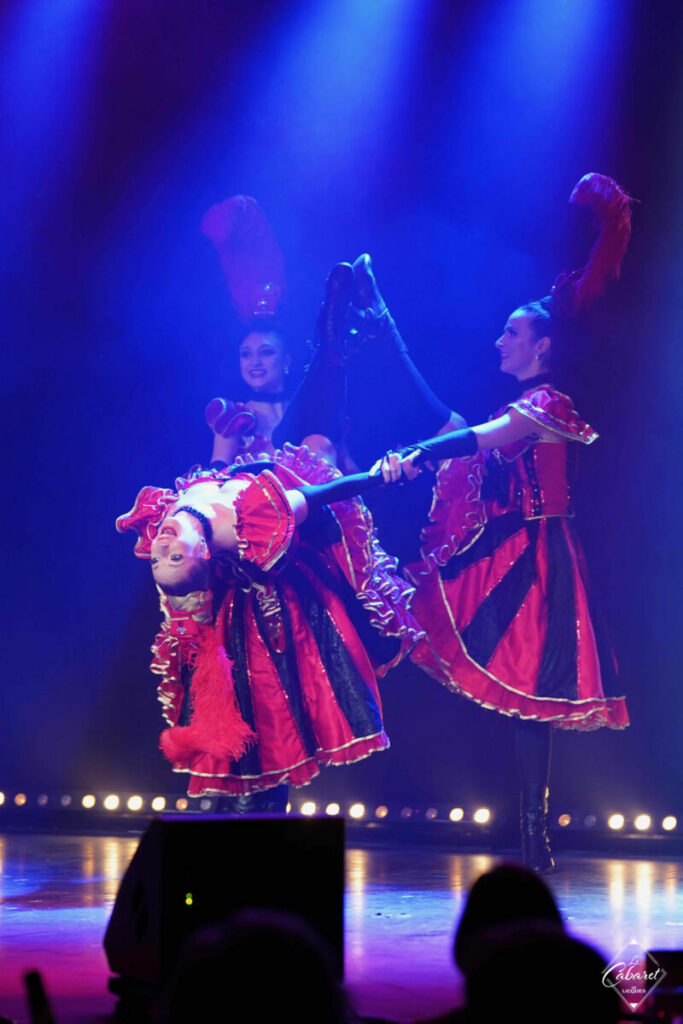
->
[411,511,629,730]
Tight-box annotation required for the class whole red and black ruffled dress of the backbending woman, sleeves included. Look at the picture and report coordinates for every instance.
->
[117,444,423,797]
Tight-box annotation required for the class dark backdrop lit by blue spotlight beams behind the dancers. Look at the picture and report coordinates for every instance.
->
[0,0,683,813]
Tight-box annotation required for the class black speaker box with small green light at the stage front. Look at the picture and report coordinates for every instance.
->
[104,815,344,994]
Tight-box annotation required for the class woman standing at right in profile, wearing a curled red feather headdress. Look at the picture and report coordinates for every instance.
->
[344,174,632,871]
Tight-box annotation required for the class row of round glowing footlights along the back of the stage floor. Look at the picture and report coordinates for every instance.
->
[0,792,678,835]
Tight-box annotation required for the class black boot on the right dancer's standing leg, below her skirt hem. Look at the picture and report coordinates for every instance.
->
[514,720,556,874]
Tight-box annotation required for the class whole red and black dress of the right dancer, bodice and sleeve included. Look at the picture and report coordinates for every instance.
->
[409,384,629,730]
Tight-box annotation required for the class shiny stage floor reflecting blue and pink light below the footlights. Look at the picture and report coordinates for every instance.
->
[0,834,683,1024]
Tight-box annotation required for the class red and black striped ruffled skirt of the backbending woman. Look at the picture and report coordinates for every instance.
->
[153,445,422,797]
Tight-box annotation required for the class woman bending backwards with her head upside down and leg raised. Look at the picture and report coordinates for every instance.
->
[117,258,421,813]
